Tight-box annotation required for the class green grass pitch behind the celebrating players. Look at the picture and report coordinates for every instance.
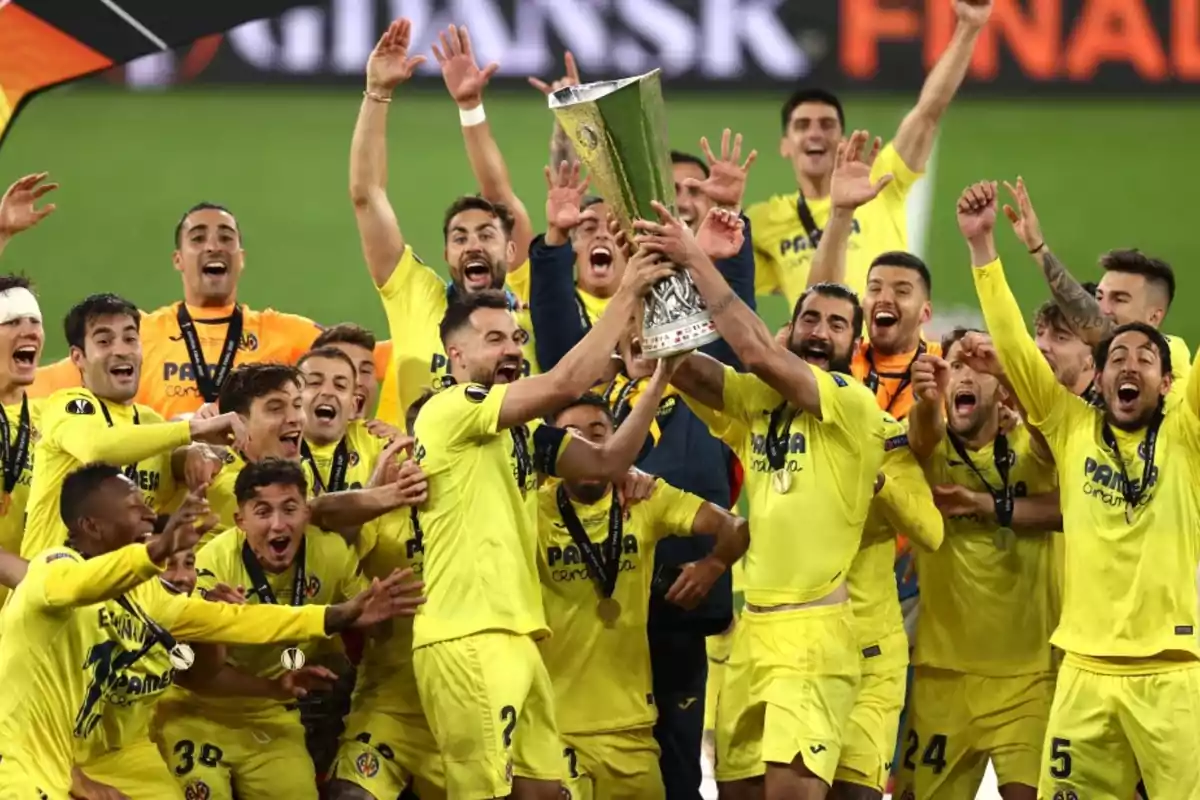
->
[0,84,1200,357]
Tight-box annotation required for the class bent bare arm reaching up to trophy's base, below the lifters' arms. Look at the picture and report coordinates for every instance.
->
[549,357,678,482]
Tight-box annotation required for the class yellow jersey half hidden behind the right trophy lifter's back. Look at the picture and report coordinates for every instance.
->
[846,415,944,666]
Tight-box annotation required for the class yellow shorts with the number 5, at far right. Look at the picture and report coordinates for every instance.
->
[1038,655,1200,800]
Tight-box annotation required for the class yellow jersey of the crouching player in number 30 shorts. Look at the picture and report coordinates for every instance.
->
[168,527,367,722]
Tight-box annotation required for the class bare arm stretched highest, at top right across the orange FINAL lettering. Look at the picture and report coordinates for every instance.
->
[893,0,992,173]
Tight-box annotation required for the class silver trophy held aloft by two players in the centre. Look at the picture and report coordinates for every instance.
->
[550,70,720,359]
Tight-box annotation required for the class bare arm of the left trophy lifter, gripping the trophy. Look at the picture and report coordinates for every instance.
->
[497,253,674,431]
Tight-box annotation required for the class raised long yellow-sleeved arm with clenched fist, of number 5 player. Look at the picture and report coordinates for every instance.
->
[958,182,1081,433]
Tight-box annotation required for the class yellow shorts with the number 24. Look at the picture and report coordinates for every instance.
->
[896,667,1055,800]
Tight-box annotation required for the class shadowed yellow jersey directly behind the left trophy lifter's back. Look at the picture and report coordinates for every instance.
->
[353,509,425,715]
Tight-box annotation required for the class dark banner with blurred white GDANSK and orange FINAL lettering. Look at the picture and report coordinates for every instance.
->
[108,0,1200,95]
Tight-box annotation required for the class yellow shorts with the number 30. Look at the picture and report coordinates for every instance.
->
[160,708,317,800]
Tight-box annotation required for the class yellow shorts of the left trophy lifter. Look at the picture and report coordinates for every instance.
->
[413,631,564,800]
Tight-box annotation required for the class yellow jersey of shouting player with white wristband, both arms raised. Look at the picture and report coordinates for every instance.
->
[377,247,538,429]
